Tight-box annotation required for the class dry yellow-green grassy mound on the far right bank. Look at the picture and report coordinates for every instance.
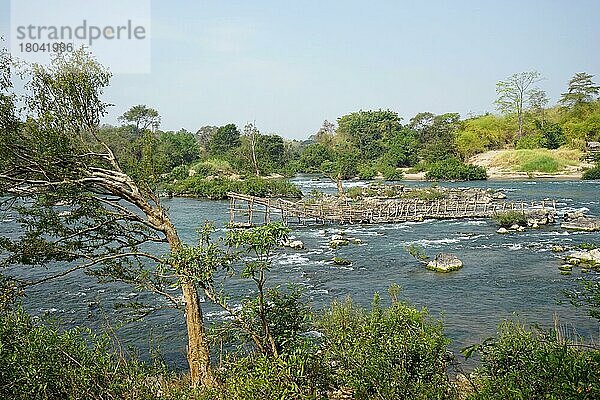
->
[492,149,581,173]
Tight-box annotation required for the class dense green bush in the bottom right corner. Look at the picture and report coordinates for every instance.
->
[468,321,600,400]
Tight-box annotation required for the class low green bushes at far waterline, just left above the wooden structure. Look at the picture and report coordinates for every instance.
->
[167,176,302,200]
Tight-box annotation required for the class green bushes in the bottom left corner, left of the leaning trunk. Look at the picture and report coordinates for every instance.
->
[0,310,166,400]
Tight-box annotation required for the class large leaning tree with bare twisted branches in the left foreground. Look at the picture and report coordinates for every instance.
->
[0,49,214,386]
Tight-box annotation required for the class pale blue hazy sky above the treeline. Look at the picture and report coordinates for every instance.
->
[0,0,600,139]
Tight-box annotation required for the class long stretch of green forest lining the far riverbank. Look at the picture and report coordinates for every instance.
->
[101,72,600,198]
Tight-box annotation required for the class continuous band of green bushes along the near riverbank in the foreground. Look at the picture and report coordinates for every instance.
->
[0,287,600,400]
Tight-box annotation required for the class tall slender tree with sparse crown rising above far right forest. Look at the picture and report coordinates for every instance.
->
[496,71,542,138]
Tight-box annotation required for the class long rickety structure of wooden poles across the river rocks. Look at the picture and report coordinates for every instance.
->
[227,192,556,227]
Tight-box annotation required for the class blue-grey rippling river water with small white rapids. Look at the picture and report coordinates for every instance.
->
[2,176,600,367]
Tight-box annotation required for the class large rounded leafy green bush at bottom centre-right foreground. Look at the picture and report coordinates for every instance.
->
[317,296,452,399]
